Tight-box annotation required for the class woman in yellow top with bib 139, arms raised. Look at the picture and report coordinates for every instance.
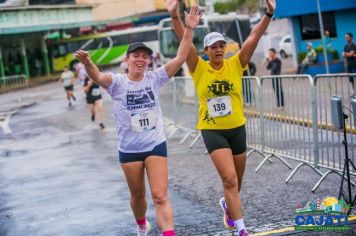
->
[167,0,276,236]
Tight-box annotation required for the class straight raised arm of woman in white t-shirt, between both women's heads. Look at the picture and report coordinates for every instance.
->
[165,6,203,77]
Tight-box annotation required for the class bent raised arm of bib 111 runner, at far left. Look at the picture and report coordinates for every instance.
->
[75,50,112,89]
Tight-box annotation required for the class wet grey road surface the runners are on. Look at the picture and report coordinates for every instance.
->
[0,80,356,235]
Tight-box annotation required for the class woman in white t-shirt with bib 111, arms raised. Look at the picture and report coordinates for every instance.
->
[76,6,201,236]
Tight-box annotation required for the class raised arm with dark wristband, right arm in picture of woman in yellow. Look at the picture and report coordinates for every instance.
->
[239,0,276,67]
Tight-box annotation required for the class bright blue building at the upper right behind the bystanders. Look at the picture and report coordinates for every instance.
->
[275,0,356,70]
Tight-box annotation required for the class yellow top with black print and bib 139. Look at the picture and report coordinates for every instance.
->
[191,54,247,130]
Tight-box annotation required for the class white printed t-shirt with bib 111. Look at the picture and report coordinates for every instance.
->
[107,67,169,153]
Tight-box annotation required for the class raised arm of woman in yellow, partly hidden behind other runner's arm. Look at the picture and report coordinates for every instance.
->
[166,0,198,72]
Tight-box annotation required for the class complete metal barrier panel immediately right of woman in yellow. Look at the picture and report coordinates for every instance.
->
[256,75,321,174]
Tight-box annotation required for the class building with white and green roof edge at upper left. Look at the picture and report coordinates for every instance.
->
[0,4,94,77]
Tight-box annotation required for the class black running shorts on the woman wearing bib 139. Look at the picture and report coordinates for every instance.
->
[201,125,247,155]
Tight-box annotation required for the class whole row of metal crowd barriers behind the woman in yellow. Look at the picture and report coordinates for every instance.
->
[161,74,356,192]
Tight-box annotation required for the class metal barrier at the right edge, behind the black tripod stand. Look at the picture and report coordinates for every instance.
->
[313,74,356,191]
